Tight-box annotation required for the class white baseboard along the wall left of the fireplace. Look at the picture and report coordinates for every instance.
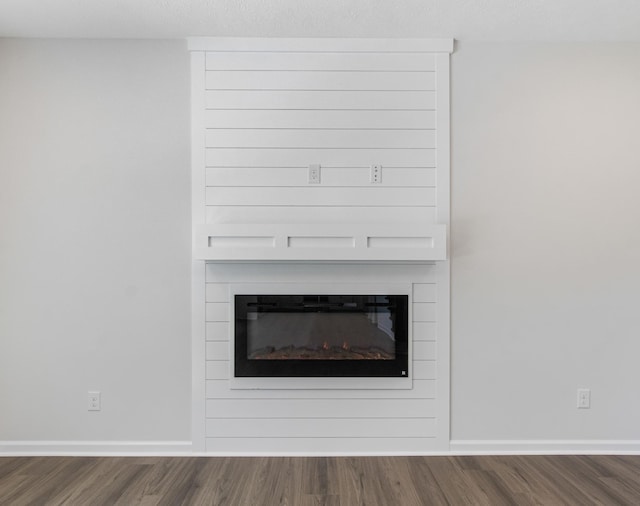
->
[0,441,194,457]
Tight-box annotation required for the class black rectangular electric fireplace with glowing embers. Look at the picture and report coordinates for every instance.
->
[234,295,409,378]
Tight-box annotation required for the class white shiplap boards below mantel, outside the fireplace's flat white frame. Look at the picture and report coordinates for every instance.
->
[205,263,446,453]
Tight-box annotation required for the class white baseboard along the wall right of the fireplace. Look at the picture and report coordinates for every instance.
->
[449,439,640,455]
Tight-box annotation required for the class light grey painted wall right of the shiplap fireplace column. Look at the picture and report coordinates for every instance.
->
[451,43,640,446]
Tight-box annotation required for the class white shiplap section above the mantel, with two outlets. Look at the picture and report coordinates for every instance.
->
[194,39,448,228]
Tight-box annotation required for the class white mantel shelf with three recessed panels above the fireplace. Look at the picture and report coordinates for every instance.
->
[194,224,447,263]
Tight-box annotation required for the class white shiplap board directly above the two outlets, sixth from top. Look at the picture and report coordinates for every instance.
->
[205,148,436,167]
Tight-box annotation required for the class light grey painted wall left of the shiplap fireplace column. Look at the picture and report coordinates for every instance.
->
[0,39,191,441]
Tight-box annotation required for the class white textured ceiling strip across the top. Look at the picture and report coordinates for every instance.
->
[0,0,640,41]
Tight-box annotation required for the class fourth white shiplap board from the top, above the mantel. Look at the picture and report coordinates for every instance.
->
[205,109,436,130]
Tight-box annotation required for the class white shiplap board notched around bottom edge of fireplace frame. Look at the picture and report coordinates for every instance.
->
[206,378,436,401]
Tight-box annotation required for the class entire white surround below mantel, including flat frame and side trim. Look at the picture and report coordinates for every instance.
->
[193,261,449,455]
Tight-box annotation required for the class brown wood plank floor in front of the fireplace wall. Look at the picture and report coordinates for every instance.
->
[0,456,640,506]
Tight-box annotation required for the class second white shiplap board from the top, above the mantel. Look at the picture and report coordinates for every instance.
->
[205,70,435,91]
